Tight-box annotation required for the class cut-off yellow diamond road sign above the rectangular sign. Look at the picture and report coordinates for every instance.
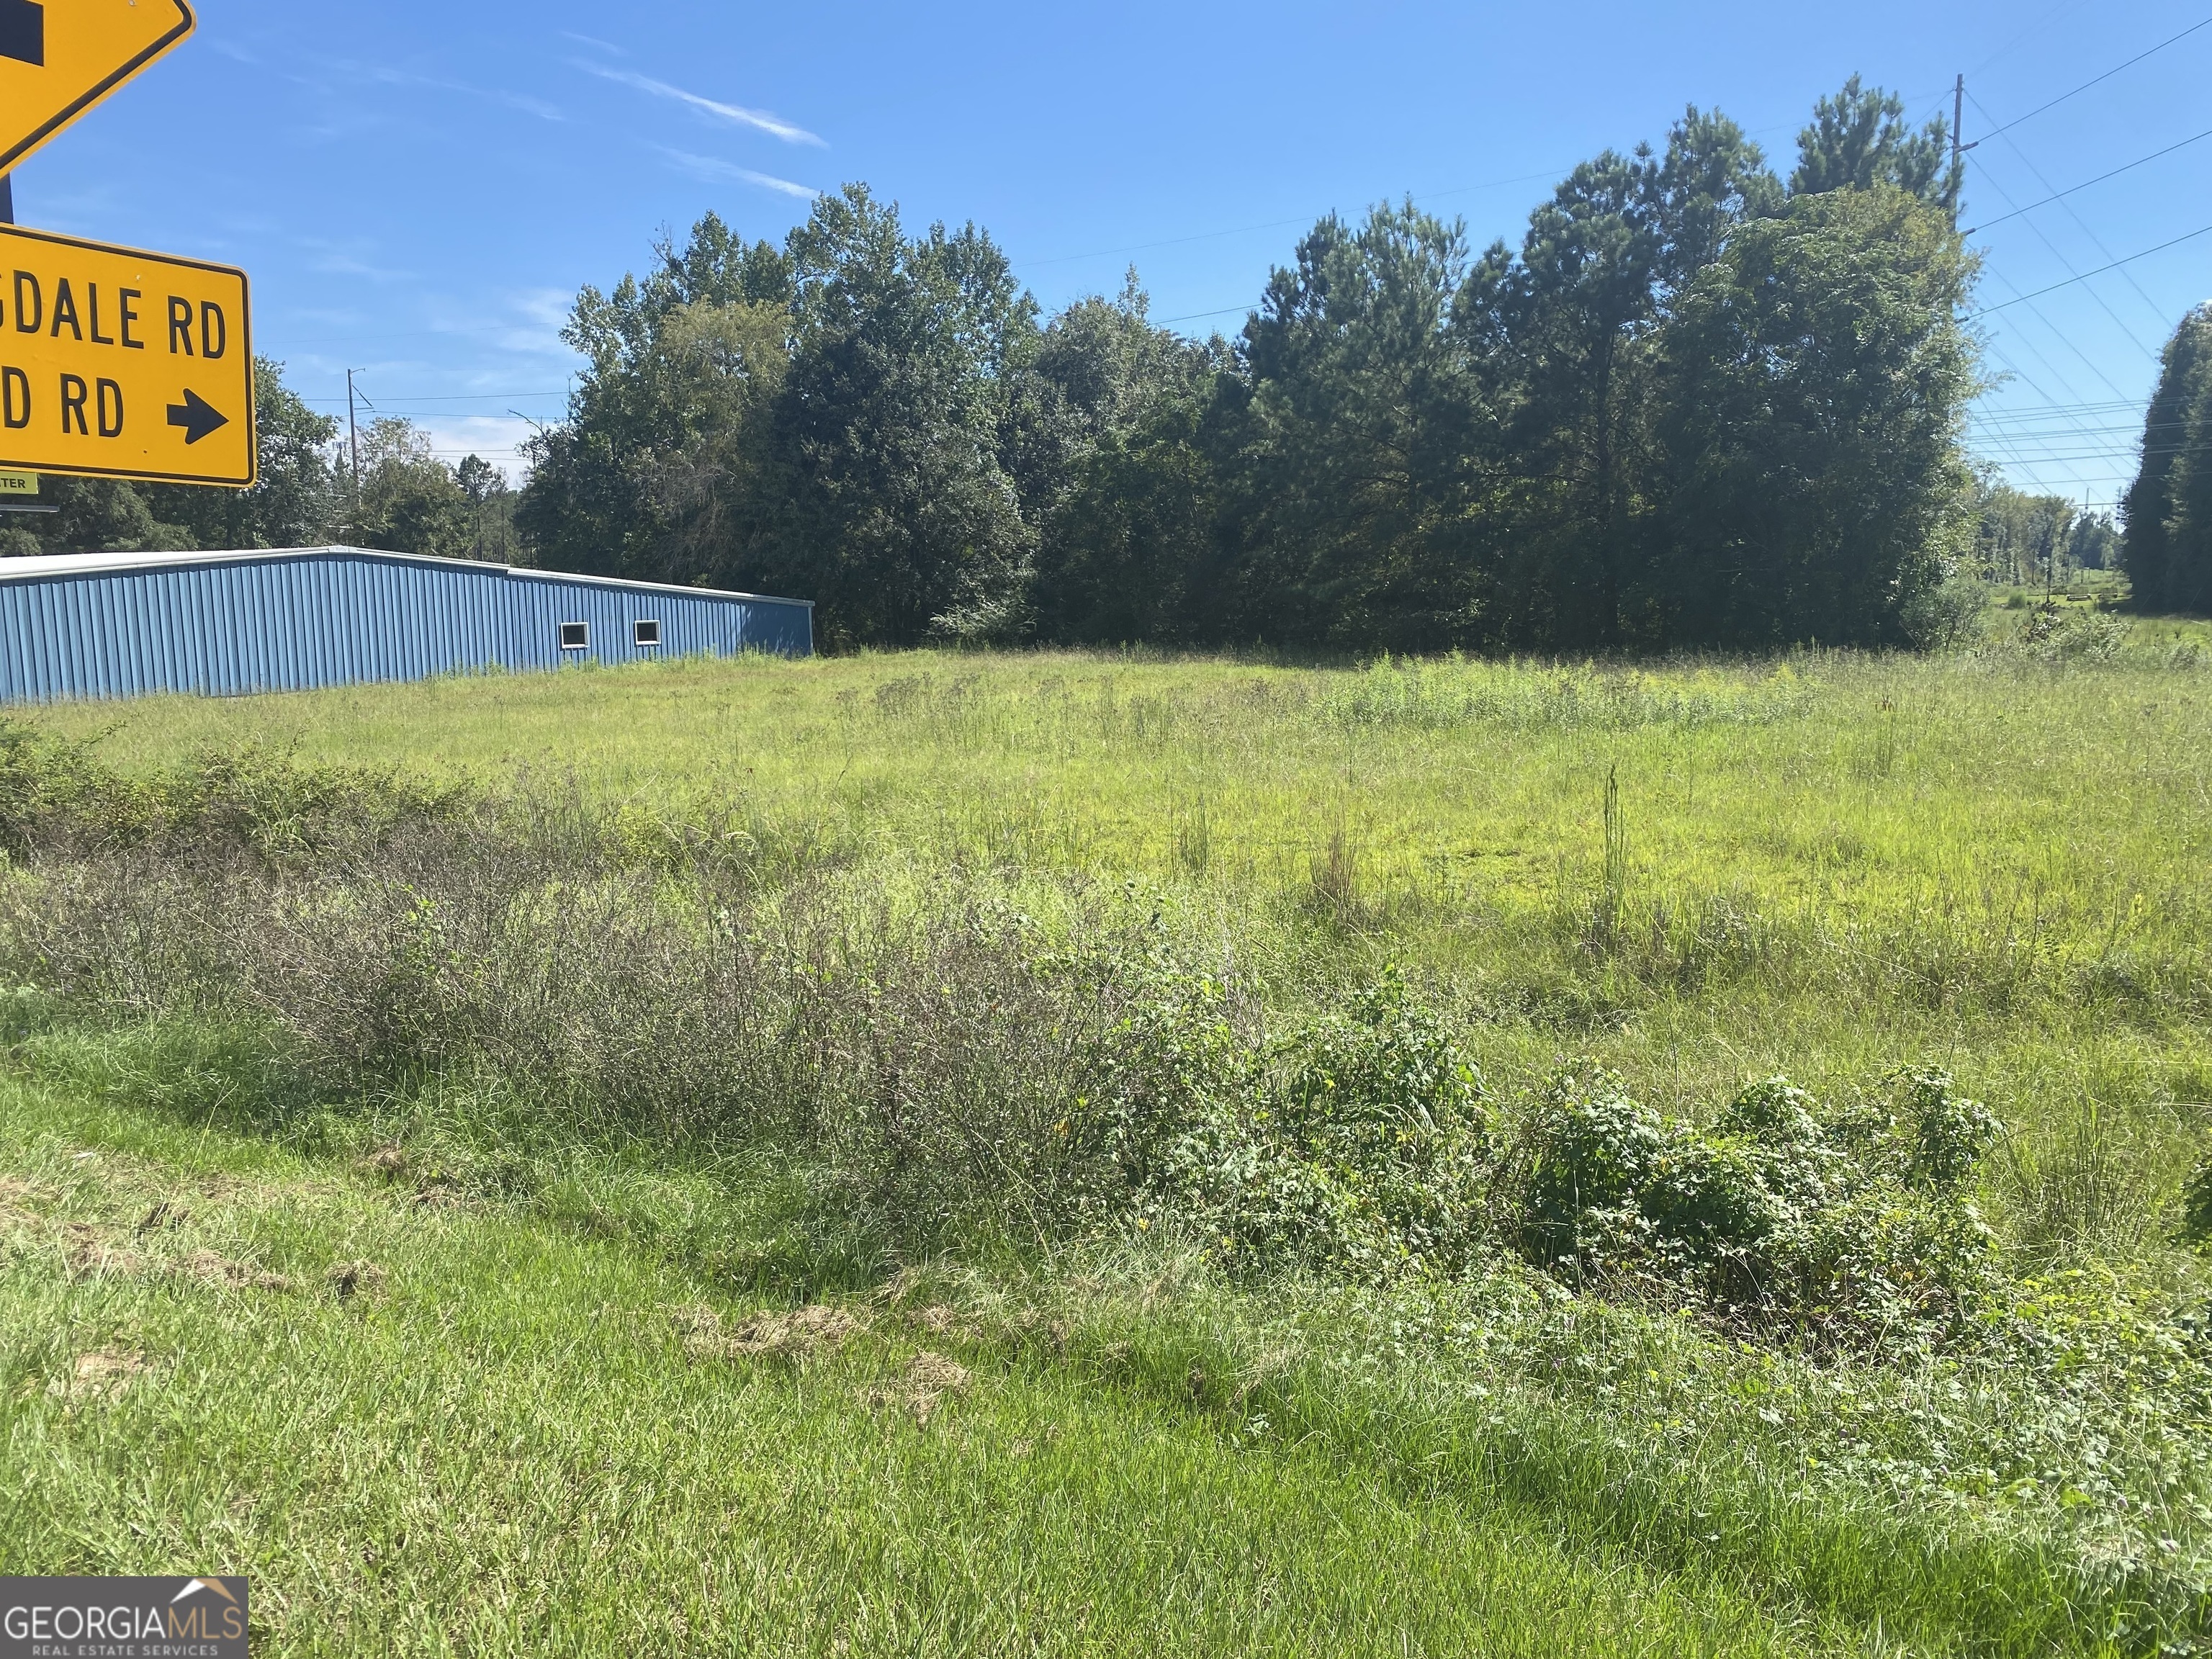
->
[0,0,197,173]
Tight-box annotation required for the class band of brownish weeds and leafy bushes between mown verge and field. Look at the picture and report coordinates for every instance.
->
[0,747,2176,1345]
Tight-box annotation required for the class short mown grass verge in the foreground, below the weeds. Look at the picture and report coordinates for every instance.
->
[0,1057,1880,1655]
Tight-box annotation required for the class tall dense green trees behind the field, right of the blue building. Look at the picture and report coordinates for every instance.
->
[518,80,1977,650]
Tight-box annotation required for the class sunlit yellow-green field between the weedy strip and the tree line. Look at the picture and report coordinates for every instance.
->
[26,642,2212,1234]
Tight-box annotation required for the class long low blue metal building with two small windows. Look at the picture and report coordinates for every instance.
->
[0,547,814,703]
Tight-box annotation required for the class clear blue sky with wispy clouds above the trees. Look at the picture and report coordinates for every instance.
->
[16,0,2212,513]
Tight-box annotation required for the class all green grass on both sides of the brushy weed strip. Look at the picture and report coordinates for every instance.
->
[13,624,2212,1653]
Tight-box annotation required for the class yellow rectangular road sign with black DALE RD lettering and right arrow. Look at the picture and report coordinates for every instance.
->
[0,221,254,487]
